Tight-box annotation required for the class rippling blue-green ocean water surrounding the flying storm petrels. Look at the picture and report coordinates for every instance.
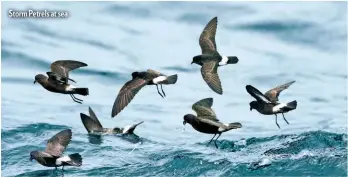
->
[1,2,347,177]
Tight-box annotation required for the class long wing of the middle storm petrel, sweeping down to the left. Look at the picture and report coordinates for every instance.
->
[111,78,148,117]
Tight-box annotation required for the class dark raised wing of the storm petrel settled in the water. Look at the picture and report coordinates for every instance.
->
[80,107,103,132]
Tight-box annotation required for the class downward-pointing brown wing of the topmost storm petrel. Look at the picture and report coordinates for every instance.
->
[201,60,222,95]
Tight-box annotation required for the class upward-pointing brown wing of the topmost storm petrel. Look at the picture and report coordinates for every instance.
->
[199,17,217,54]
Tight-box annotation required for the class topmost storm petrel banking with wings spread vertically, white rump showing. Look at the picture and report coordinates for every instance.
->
[191,17,239,95]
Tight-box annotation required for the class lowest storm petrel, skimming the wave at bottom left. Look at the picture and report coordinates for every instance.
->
[29,129,82,170]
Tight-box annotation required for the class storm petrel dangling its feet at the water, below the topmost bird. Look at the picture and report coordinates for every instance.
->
[183,98,242,148]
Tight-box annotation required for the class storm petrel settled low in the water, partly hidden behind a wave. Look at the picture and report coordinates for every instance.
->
[80,107,144,134]
